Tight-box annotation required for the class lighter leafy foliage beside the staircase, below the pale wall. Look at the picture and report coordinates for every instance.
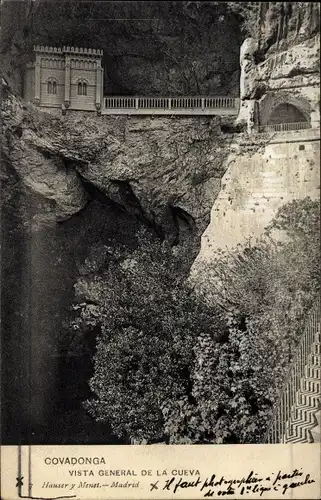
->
[193,198,320,443]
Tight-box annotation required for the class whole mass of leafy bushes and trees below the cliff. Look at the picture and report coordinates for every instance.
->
[69,198,319,443]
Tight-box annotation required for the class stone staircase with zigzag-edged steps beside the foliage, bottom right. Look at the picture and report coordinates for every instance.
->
[265,300,321,444]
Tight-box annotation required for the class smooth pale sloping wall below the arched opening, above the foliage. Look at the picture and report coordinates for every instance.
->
[195,129,320,266]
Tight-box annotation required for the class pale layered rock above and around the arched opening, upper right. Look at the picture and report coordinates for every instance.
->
[234,2,320,130]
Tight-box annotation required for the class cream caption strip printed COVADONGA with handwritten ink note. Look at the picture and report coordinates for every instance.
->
[1,444,320,500]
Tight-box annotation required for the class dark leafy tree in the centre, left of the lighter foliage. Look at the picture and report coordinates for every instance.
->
[70,230,223,442]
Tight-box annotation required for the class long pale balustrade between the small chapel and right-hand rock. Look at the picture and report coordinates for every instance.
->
[102,96,239,115]
